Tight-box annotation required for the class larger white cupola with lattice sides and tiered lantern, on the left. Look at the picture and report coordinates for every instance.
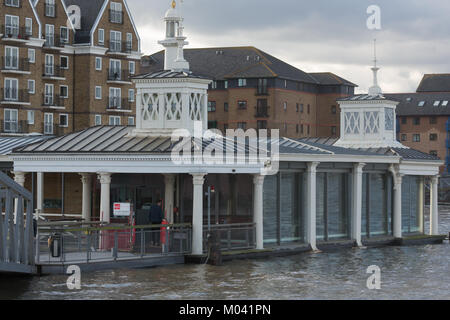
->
[132,1,211,136]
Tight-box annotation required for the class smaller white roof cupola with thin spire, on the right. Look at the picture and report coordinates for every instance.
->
[335,40,406,148]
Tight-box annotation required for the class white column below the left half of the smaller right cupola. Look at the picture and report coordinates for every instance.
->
[352,163,366,247]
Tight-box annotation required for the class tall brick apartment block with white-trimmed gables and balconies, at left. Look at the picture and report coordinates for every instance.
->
[0,0,140,135]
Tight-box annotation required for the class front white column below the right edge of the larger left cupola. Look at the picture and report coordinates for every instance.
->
[192,173,206,255]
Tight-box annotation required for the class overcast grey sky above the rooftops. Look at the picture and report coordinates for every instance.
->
[128,0,450,93]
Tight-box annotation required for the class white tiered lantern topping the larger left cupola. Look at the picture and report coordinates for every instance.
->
[158,0,189,71]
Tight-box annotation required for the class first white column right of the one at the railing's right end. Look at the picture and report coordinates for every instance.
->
[306,162,319,251]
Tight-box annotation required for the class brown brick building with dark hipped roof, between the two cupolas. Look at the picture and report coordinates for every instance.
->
[141,47,356,138]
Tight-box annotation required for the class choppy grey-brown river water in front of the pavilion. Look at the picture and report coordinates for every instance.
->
[0,209,450,300]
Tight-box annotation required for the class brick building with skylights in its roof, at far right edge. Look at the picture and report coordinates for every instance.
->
[385,74,450,175]
